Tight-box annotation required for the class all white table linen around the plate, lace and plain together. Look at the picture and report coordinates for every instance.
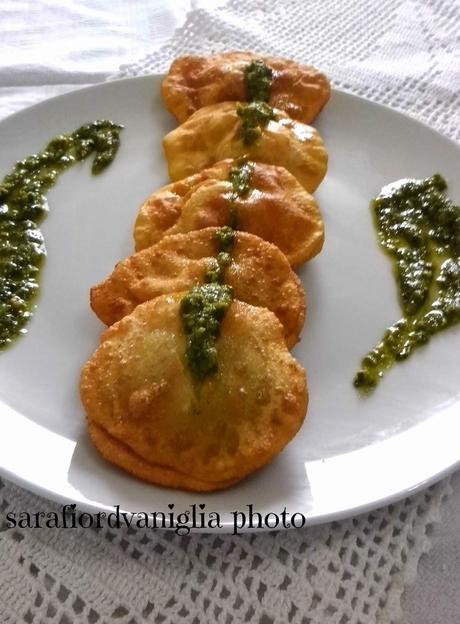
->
[0,0,460,624]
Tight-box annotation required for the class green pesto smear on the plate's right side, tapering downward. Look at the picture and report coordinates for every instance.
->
[354,174,460,390]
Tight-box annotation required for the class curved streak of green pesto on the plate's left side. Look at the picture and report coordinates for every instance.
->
[0,121,122,349]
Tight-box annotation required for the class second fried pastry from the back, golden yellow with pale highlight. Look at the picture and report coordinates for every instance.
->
[163,102,327,193]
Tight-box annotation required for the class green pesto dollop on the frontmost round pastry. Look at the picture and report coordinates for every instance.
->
[180,283,233,381]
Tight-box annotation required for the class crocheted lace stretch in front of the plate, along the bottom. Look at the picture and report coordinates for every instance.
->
[0,481,449,624]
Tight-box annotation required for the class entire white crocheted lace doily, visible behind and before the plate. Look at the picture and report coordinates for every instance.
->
[0,0,460,624]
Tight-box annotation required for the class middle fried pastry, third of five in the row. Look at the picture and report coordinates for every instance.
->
[134,160,324,266]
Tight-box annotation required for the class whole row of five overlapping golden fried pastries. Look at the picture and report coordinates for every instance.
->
[80,53,329,491]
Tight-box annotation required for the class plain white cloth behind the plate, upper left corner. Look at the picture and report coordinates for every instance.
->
[0,0,192,117]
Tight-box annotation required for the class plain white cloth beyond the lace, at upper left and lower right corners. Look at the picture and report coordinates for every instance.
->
[0,0,460,624]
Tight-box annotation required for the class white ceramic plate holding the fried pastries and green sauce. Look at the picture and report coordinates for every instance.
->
[0,77,460,530]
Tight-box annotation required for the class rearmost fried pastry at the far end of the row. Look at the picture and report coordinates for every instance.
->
[161,52,331,124]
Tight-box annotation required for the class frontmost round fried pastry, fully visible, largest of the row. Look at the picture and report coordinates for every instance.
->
[80,294,308,491]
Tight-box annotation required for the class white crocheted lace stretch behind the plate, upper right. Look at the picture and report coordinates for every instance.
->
[116,0,460,140]
